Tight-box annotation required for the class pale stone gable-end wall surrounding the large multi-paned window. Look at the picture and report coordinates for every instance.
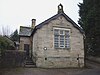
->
[33,16,84,68]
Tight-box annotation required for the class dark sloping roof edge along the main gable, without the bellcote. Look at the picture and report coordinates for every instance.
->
[35,12,84,34]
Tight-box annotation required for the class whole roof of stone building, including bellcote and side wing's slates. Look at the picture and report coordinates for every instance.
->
[19,4,84,36]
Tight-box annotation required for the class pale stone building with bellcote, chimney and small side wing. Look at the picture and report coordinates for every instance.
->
[19,4,84,68]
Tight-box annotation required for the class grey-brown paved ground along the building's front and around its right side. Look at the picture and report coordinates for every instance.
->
[0,61,100,75]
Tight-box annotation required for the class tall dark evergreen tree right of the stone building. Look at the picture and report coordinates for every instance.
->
[78,0,100,55]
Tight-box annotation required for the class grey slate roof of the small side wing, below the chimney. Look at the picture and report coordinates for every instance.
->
[19,26,32,36]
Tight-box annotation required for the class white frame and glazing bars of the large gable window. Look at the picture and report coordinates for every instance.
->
[53,27,70,49]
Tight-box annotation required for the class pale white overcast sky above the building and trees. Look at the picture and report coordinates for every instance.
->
[0,0,82,34]
